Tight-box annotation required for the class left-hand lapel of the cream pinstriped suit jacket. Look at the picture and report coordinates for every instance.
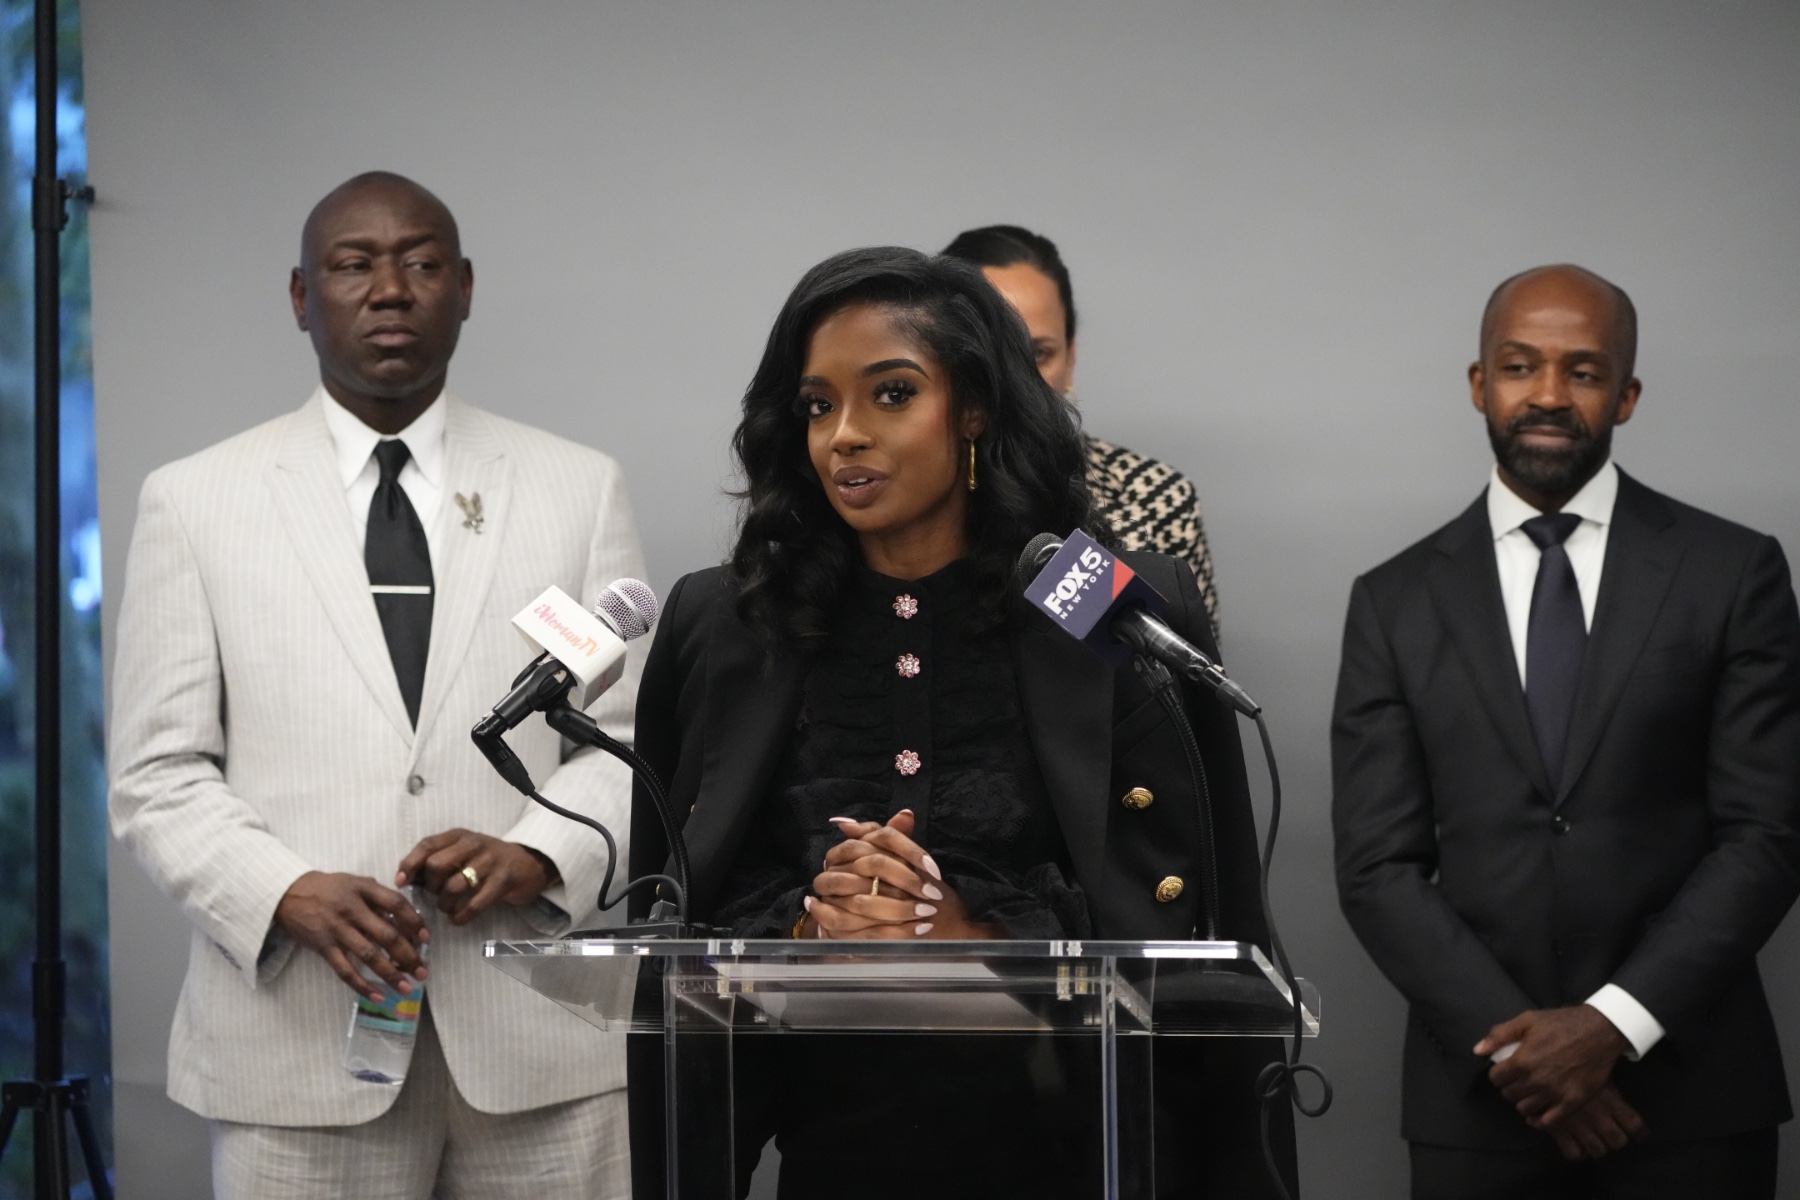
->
[268,396,412,741]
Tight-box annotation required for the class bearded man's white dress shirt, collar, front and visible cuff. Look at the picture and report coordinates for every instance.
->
[1487,461,1663,1060]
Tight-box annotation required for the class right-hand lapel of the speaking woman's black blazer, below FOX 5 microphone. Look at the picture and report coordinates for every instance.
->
[1013,612,1114,906]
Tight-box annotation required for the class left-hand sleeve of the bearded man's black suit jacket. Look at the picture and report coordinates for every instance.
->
[1332,579,1534,1081]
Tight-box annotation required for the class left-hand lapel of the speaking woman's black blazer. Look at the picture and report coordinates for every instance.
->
[675,626,806,912]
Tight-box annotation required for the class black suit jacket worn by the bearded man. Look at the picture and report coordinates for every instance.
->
[1332,473,1800,1148]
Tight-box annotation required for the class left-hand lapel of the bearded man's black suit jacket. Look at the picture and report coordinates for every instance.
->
[1426,495,1550,795]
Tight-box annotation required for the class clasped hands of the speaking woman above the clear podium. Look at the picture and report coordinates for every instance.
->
[805,810,999,939]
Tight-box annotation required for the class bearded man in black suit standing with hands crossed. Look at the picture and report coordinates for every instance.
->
[1332,266,1800,1198]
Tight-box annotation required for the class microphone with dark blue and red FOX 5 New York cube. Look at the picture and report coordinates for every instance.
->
[1013,529,1262,718]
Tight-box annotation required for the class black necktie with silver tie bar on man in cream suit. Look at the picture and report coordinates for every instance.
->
[362,439,432,727]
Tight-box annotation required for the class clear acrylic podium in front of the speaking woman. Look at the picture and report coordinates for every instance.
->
[486,930,1319,1200]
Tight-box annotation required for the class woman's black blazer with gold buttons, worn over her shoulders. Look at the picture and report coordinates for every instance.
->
[630,554,1294,1195]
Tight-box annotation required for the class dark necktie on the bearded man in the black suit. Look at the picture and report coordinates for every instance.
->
[1525,513,1588,790]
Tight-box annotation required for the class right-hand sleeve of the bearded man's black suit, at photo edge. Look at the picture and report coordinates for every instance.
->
[1613,538,1800,1036]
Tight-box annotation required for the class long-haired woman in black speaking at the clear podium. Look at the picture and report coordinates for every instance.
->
[632,248,1292,1200]
